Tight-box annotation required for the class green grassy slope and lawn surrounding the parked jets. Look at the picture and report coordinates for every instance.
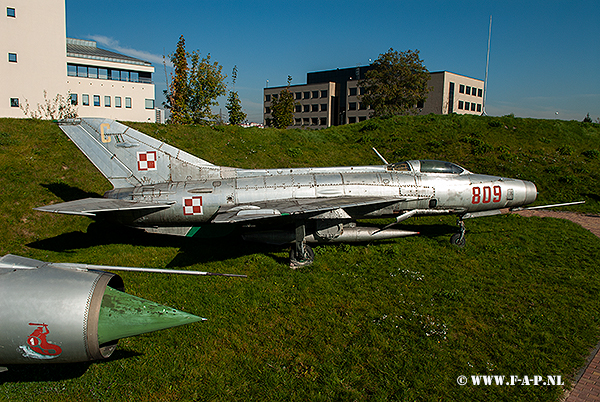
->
[0,116,600,401]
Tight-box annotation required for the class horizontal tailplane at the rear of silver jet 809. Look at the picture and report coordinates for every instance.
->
[34,198,173,217]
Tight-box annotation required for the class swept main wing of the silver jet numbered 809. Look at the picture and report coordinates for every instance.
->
[212,197,408,223]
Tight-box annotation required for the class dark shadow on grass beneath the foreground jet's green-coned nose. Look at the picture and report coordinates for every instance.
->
[0,349,142,384]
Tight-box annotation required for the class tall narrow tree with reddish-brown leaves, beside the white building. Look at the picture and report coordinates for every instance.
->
[164,35,191,124]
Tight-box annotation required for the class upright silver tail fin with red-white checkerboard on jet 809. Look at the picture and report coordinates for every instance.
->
[58,118,220,188]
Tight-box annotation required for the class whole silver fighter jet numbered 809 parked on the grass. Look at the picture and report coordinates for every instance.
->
[36,118,566,267]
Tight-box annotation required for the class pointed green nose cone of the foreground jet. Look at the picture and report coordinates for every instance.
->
[98,287,205,345]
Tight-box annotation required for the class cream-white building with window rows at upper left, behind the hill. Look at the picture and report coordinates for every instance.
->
[0,0,156,122]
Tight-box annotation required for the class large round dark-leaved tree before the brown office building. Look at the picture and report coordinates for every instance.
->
[359,48,430,116]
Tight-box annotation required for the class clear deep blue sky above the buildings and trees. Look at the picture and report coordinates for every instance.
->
[66,0,600,122]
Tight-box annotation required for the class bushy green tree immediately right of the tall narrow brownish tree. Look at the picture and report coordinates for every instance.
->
[189,51,227,124]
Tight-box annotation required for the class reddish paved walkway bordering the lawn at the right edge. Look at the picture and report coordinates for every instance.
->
[517,210,600,402]
